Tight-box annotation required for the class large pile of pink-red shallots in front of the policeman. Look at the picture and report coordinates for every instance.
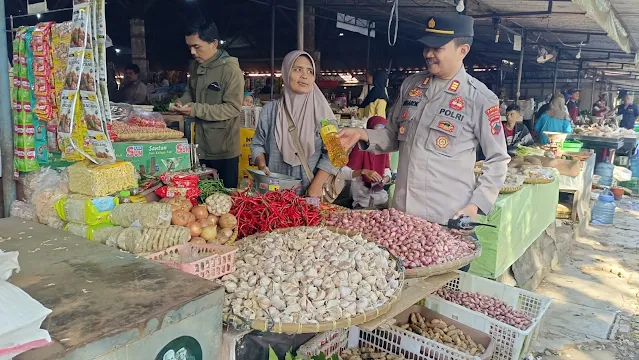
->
[326,209,476,269]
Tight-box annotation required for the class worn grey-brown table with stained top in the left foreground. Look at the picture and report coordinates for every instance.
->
[0,218,224,360]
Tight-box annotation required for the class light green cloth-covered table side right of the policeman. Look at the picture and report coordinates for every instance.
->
[470,174,559,279]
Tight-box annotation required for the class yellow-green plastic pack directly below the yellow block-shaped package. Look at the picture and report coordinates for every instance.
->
[55,194,120,224]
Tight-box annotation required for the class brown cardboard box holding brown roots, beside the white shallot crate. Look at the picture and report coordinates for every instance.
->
[394,305,495,360]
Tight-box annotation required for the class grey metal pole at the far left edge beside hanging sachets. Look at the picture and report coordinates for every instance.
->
[0,0,16,217]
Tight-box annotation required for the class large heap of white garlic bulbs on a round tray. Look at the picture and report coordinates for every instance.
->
[222,227,400,324]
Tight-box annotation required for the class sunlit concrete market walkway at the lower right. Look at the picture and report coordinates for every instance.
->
[533,197,639,360]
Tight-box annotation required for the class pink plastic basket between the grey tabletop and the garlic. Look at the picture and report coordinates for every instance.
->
[146,244,237,280]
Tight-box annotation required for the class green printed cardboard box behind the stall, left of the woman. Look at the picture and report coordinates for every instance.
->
[113,139,191,175]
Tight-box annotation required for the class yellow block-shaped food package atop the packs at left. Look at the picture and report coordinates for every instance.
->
[67,161,138,196]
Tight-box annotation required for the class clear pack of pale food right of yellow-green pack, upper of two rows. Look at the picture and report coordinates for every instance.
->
[110,203,172,228]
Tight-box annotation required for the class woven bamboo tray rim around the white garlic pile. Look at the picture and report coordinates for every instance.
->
[223,226,405,334]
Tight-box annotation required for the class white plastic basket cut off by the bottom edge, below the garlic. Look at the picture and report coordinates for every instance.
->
[297,326,488,360]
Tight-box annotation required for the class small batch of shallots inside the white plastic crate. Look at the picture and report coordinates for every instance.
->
[435,288,532,330]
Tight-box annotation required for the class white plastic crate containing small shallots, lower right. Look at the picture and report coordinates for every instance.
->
[426,271,552,360]
